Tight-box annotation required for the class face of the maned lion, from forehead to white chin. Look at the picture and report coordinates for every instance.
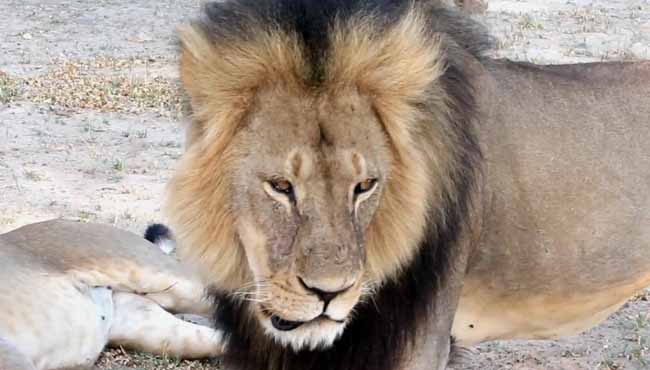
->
[232,89,390,349]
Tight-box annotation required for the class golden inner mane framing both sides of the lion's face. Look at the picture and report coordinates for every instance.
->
[166,8,464,289]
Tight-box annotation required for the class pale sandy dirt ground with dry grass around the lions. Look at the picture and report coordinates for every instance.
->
[0,0,650,370]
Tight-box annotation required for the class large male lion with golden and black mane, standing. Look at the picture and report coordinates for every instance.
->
[159,0,650,370]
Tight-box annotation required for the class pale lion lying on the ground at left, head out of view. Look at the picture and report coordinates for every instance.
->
[0,220,223,370]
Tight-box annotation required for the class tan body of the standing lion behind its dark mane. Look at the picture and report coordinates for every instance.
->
[454,62,650,343]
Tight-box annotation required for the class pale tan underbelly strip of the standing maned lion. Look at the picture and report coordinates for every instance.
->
[452,272,650,345]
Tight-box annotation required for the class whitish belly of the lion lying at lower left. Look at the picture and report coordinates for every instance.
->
[0,266,113,369]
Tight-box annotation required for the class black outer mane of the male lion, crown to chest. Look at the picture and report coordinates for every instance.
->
[198,0,488,370]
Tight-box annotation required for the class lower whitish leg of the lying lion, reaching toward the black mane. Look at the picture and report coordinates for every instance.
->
[109,292,223,358]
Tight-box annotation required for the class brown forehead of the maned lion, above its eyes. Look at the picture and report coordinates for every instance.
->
[248,89,388,175]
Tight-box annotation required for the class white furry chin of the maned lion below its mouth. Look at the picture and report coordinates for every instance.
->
[260,317,347,351]
